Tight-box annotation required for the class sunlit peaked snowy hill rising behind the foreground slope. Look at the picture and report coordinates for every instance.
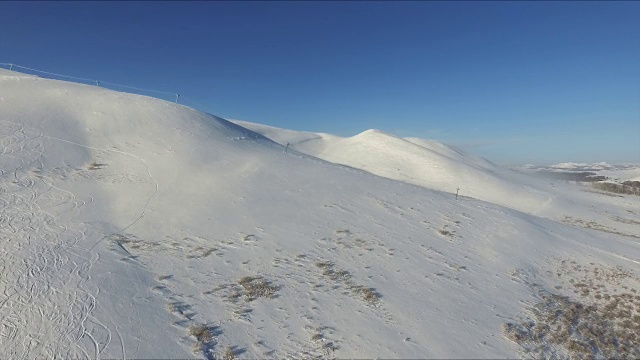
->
[234,121,558,214]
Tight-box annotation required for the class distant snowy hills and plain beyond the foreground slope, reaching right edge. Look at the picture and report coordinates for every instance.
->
[233,120,640,233]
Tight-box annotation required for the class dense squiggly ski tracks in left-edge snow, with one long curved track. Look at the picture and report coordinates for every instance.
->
[0,121,158,359]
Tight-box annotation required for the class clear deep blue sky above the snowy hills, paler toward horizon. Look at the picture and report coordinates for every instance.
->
[0,1,640,164]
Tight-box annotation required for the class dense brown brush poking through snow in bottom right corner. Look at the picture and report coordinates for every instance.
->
[503,260,640,359]
